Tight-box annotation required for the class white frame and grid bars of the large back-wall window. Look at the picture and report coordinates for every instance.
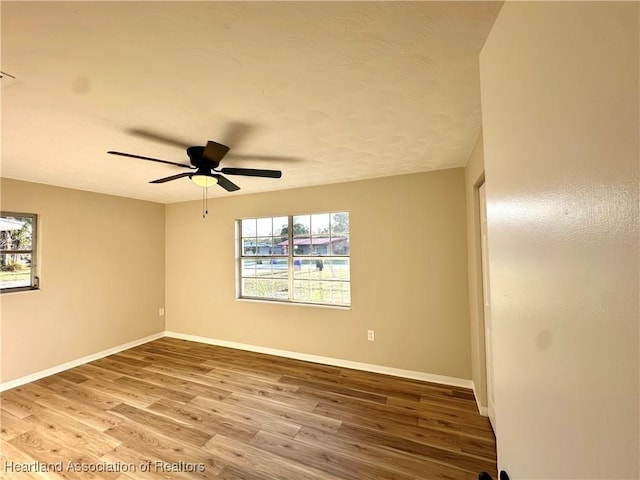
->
[235,210,352,309]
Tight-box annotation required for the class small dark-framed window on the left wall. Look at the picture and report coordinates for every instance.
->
[0,212,38,292]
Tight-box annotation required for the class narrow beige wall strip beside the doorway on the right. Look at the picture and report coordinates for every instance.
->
[464,131,487,408]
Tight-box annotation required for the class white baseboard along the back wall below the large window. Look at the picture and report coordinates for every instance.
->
[165,331,477,392]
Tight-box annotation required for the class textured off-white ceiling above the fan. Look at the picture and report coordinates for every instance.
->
[0,1,501,203]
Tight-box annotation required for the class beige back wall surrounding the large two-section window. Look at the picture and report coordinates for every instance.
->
[166,169,471,379]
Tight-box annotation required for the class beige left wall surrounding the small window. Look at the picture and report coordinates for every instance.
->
[0,179,165,382]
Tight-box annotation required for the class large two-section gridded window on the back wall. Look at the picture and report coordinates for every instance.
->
[238,212,351,306]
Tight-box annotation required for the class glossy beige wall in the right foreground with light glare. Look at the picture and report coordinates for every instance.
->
[480,2,640,480]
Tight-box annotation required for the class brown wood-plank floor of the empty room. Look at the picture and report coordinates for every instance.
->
[0,338,497,480]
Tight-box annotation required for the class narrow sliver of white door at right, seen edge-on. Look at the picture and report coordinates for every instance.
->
[478,183,496,432]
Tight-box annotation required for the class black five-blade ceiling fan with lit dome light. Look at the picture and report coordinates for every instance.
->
[107,140,282,192]
